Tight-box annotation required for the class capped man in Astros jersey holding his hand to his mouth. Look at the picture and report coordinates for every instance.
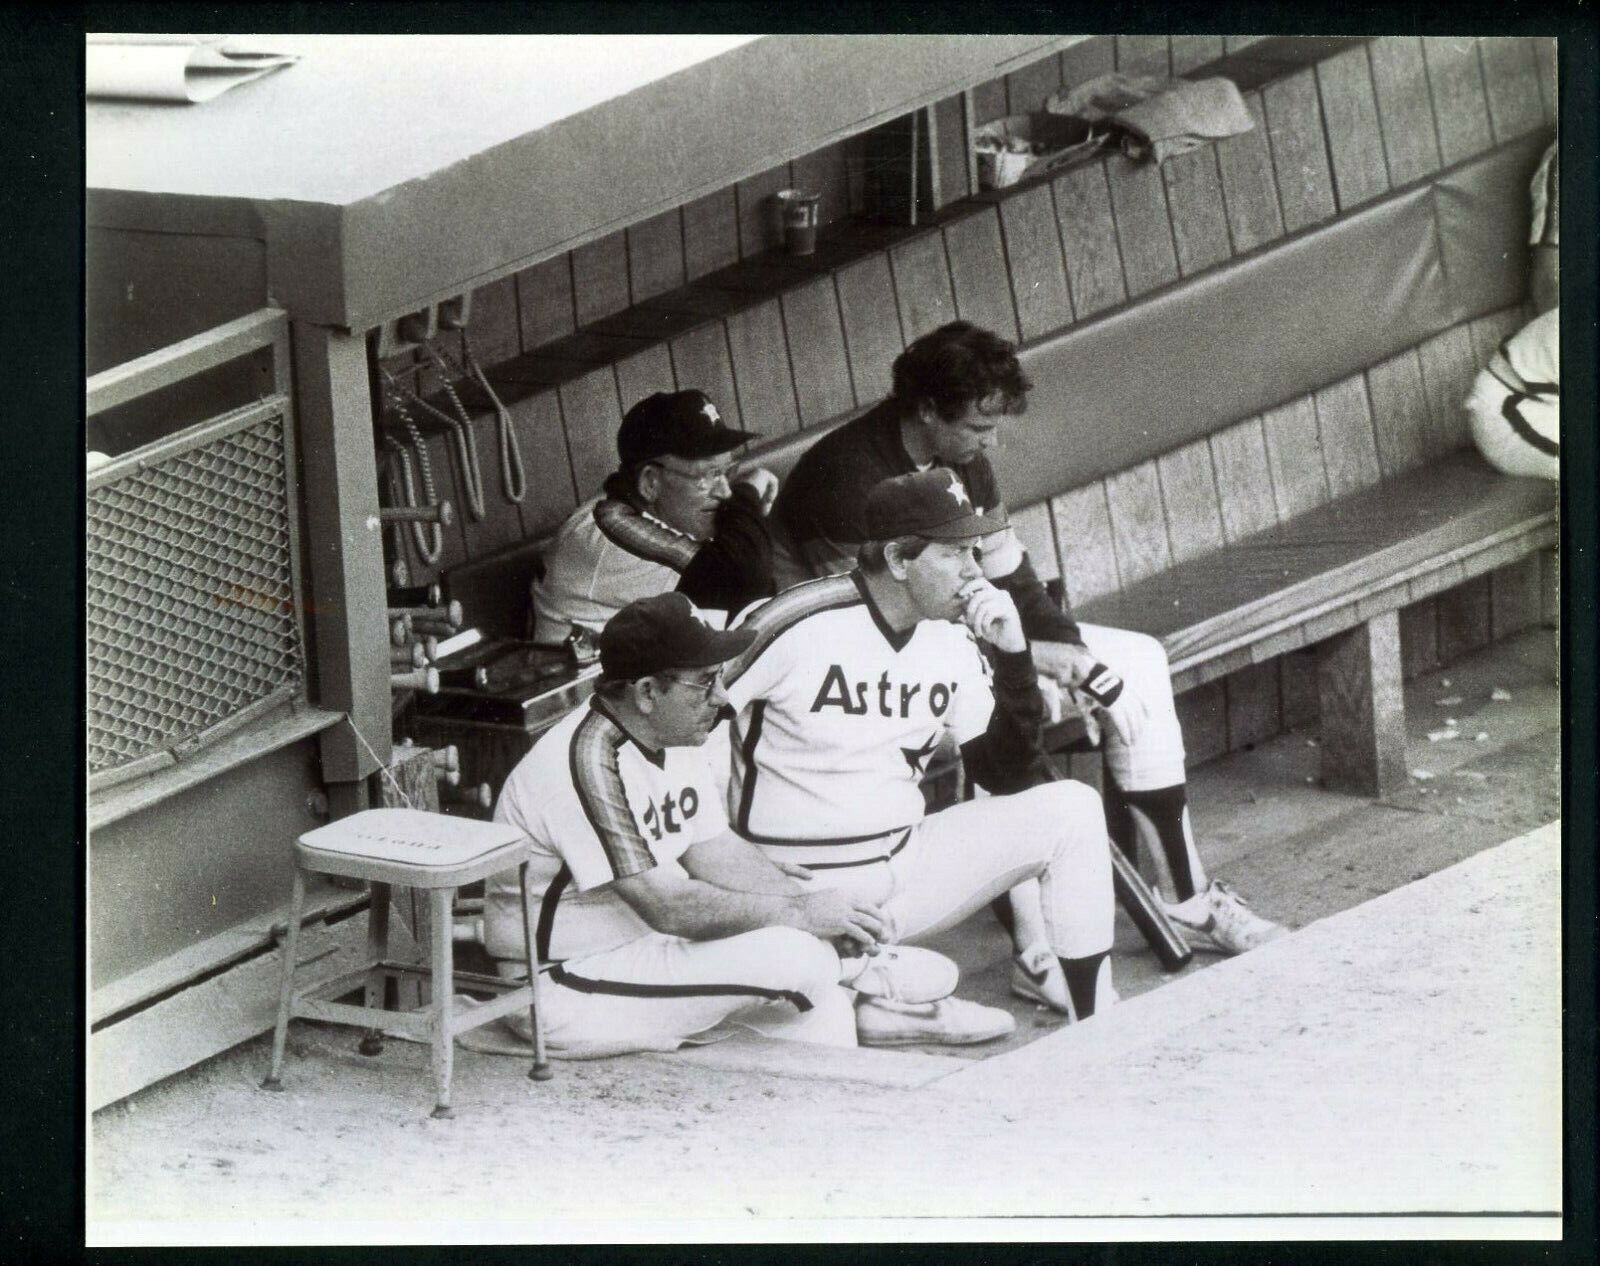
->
[723,471,1115,1045]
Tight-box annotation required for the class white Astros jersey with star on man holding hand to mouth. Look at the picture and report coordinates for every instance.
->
[723,573,994,866]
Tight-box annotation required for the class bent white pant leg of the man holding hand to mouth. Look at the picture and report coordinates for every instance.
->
[864,783,1114,959]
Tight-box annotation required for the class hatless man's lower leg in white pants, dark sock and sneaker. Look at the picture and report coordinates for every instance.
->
[1082,624,1283,954]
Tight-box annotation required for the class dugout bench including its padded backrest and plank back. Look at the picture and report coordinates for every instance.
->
[432,128,1557,795]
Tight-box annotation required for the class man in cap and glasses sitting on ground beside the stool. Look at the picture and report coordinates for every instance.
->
[485,594,957,1060]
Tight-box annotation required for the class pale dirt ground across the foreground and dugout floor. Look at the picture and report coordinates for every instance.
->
[88,632,1560,1244]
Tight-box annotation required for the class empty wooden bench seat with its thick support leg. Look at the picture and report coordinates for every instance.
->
[1062,451,1557,795]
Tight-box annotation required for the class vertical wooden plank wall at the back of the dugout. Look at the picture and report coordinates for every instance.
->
[374,35,1555,761]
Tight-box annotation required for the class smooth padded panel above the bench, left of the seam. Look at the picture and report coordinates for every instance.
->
[997,189,1450,506]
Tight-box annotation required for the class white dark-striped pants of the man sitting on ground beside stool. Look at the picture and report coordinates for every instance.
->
[539,927,856,1060]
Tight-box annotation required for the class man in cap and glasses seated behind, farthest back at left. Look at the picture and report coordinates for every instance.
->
[533,391,778,647]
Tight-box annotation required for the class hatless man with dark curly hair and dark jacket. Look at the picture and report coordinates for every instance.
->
[773,322,1283,966]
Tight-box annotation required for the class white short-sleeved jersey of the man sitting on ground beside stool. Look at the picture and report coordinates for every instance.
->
[485,695,728,962]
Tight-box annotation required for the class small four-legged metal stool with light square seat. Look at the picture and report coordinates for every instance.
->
[262,808,550,1117]
